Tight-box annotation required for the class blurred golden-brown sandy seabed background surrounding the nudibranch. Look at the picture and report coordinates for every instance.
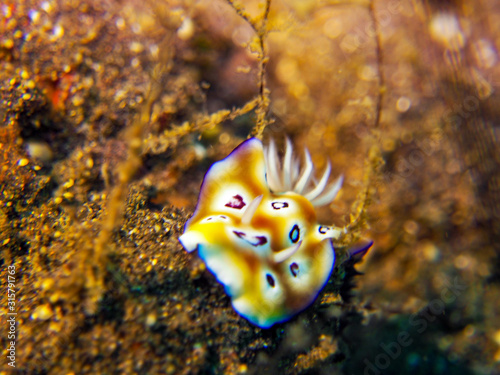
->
[0,0,500,374]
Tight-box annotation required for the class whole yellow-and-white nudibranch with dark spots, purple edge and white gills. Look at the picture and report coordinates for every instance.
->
[179,138,348,328]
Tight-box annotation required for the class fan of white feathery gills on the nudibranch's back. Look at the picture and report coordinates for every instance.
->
[264,138,344,207]
